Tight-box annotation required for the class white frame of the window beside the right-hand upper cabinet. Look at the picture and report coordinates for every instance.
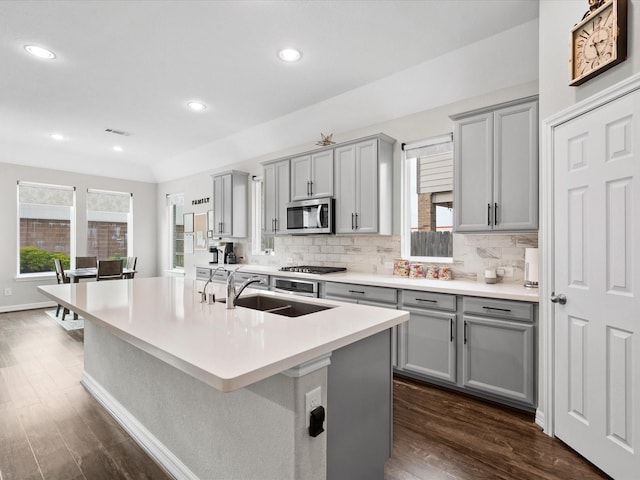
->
[400,133,455,263]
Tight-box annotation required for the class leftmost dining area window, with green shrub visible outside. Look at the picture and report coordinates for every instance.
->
[17,182,75,275]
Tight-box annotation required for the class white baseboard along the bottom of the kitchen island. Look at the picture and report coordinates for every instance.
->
[80,372,198,480]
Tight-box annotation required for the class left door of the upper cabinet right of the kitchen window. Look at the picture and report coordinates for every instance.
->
[453,113,493,232]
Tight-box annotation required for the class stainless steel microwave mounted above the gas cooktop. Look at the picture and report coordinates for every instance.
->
[286,197,335,235]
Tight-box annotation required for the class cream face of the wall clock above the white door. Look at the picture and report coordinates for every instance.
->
[573,8,615,78]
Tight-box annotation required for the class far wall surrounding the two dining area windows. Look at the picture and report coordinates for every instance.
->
[0,163,157,312]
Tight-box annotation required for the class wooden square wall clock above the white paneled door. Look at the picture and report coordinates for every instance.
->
[569,0,627,86]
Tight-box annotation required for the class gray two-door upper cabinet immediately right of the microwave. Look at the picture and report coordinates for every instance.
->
[335,134,395,235]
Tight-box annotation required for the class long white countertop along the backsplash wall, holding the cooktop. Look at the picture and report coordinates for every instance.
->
[197,264,539,303]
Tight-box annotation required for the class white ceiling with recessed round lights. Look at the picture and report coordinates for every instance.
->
[0,0,538,181]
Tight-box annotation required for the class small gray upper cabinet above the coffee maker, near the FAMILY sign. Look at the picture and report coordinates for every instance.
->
[209,170,249,238]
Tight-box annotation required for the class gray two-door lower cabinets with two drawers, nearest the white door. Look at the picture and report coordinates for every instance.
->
[396,290,537,410]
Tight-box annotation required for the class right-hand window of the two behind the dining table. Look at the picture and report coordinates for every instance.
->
[87,189,133,259]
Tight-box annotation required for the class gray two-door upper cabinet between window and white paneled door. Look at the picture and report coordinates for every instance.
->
[451,97,538,232]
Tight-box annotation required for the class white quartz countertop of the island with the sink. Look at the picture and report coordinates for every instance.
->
[38,277,409,392]
